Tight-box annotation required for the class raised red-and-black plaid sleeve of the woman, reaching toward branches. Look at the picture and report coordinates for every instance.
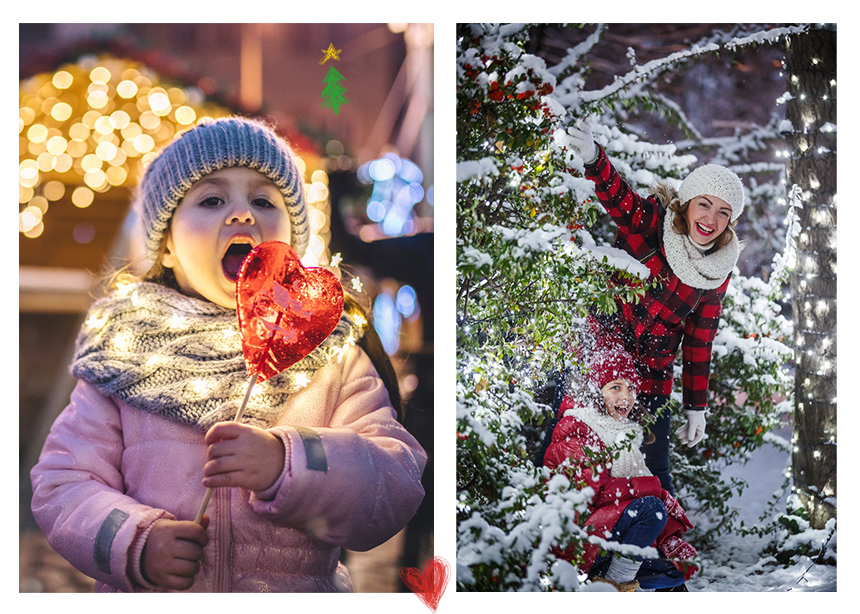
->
[585,145,660,243]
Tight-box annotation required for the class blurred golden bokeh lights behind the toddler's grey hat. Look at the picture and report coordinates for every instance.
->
[18,55,331,266]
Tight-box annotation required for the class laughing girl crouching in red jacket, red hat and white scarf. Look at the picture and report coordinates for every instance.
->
[544,336,696,592]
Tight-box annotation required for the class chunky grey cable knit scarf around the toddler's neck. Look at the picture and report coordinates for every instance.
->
[71,282,361,430]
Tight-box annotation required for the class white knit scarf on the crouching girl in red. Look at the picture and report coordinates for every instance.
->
[565,407,651,478]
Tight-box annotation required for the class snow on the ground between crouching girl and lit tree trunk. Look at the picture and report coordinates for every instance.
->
[687,431,836,592]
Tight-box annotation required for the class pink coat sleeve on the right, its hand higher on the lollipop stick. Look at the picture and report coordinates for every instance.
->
[251,348,427,550]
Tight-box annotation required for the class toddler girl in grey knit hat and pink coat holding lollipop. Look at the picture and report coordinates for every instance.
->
[31,118,426,592]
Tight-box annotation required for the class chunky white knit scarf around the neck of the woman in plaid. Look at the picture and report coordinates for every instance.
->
[663,209,740,290]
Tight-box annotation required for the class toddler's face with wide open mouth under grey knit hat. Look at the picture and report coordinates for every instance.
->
[162,166,290,307]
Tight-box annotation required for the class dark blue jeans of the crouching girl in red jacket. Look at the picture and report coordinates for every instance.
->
[589,497,684,589]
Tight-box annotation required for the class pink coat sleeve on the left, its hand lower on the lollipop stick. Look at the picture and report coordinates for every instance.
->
[30,382,173,591]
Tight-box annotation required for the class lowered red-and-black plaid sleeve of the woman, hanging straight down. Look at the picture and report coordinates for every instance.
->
[681,276,731,409]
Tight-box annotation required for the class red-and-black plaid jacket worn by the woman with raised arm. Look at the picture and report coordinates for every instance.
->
[585,149,731,409]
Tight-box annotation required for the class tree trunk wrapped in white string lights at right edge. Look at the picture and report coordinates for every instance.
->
[786,29,836,528]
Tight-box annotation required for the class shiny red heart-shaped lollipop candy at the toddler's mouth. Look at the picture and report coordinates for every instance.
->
[236,241,343,382]
